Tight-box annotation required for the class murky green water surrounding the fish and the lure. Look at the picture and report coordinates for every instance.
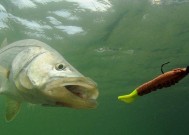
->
[0,0,189,135]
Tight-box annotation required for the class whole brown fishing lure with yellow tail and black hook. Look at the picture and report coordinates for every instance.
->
[118,62,189,103]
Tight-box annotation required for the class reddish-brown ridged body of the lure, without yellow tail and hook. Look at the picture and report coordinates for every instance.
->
[136,67,189,96]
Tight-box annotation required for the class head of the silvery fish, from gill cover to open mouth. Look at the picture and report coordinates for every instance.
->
[16,48,98,108]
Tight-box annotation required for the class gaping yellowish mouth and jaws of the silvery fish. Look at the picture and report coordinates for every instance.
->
[44,77,99,109]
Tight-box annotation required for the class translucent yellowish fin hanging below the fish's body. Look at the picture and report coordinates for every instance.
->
[5,98,21,122]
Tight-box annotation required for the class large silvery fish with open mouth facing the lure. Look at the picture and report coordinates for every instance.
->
[0,39,99,122]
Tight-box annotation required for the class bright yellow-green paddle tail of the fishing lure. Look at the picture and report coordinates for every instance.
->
[118,90,138,103]
